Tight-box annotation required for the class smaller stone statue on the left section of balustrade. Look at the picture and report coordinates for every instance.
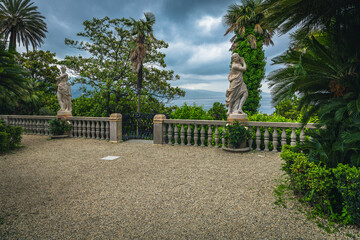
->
[56,66,72,113]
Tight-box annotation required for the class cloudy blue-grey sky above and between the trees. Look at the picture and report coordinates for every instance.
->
[28,0,288,92]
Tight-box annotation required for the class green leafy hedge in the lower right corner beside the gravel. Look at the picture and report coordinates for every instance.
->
[280,146,360,224]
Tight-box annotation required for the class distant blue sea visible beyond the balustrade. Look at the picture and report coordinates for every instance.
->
[166,89,275,114]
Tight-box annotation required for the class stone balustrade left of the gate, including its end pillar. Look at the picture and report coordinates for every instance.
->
[0,113,122,142]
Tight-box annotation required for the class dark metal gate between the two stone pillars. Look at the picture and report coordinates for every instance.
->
[122,113,156,141]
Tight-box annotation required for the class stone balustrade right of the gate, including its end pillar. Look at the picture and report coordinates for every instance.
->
[154,115,315,151]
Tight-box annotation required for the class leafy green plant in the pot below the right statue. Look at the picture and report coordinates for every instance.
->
[225,120,250,148]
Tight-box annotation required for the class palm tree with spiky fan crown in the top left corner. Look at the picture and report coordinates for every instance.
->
[0,0,47,50]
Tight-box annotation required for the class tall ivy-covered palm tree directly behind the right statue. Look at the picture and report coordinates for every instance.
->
[224,0,273,113]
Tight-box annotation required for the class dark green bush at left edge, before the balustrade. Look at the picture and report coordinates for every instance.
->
[0,120,23,153]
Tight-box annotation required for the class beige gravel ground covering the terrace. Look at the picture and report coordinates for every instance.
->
[0,136,360,239]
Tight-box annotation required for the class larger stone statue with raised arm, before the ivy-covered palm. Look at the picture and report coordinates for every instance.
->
[226,53,248,115]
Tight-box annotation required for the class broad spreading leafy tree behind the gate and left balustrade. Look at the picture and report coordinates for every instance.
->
[62,17,185,116]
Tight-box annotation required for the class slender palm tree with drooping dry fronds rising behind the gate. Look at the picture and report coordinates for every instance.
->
[130,12,157,113]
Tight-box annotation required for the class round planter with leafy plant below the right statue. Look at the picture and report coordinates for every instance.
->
[223,120,250,152]
